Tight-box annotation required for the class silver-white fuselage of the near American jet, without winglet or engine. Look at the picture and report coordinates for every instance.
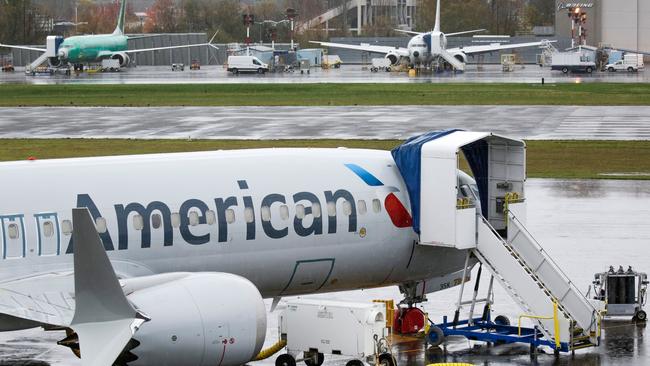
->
[0,149,465,297]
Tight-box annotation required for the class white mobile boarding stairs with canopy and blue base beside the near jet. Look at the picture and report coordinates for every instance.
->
[393,130,601,352]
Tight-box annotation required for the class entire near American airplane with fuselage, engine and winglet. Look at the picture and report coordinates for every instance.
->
[0,142,480,366]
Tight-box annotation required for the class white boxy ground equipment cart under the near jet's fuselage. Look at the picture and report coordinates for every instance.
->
[279,299,388,365]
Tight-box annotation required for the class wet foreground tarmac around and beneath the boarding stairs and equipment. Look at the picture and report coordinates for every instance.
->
[0,179,650,366]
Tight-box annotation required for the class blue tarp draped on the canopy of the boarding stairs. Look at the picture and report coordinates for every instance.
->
[391,129,488,234]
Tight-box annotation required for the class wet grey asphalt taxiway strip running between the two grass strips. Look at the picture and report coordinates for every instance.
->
[0,106,650,140]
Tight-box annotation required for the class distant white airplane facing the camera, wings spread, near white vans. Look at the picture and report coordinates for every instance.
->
[310,0,555,71]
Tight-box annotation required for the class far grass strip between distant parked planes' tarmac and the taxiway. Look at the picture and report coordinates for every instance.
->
[0,83,650,107]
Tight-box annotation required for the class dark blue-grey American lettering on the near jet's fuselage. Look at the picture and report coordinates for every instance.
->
[66,181,357,254]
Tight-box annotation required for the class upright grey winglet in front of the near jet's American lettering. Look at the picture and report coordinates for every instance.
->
[70,208,147,366]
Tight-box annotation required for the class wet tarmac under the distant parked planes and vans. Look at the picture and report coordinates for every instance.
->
[0,65,650,84]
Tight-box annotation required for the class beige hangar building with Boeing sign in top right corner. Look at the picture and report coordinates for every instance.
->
[555,0,650,57]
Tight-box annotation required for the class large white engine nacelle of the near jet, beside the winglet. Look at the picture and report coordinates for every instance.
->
[123,273,266,366]
